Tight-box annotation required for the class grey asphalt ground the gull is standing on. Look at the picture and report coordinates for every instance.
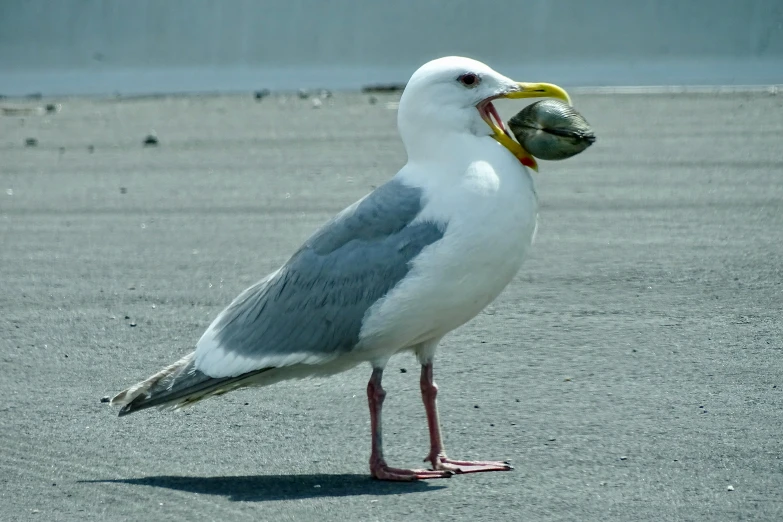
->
[0,93,783,521]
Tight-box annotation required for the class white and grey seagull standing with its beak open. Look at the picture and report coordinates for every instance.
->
[111,56,570,481]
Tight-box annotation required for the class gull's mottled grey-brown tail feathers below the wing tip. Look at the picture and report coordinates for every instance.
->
[111,352,271,417]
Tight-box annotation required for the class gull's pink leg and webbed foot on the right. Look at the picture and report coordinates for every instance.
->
[421,363,514,473]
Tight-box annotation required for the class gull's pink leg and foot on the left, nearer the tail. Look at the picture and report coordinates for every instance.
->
[367,368,454,481]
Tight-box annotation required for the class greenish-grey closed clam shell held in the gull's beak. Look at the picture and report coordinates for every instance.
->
[508,100,595,160]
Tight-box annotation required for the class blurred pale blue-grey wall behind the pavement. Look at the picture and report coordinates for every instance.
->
[0,0,783,95]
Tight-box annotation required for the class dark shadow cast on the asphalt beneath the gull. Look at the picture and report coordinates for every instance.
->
[82,474,445,502]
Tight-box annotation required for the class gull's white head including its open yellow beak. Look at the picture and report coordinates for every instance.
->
[397,56,570,169]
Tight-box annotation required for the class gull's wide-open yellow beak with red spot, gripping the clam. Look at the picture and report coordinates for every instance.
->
[476,82,571,171]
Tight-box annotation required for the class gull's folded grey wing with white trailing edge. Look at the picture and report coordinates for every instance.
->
[196,180,446,377]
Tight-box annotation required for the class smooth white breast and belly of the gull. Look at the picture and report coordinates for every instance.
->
[360,138,538,351]
